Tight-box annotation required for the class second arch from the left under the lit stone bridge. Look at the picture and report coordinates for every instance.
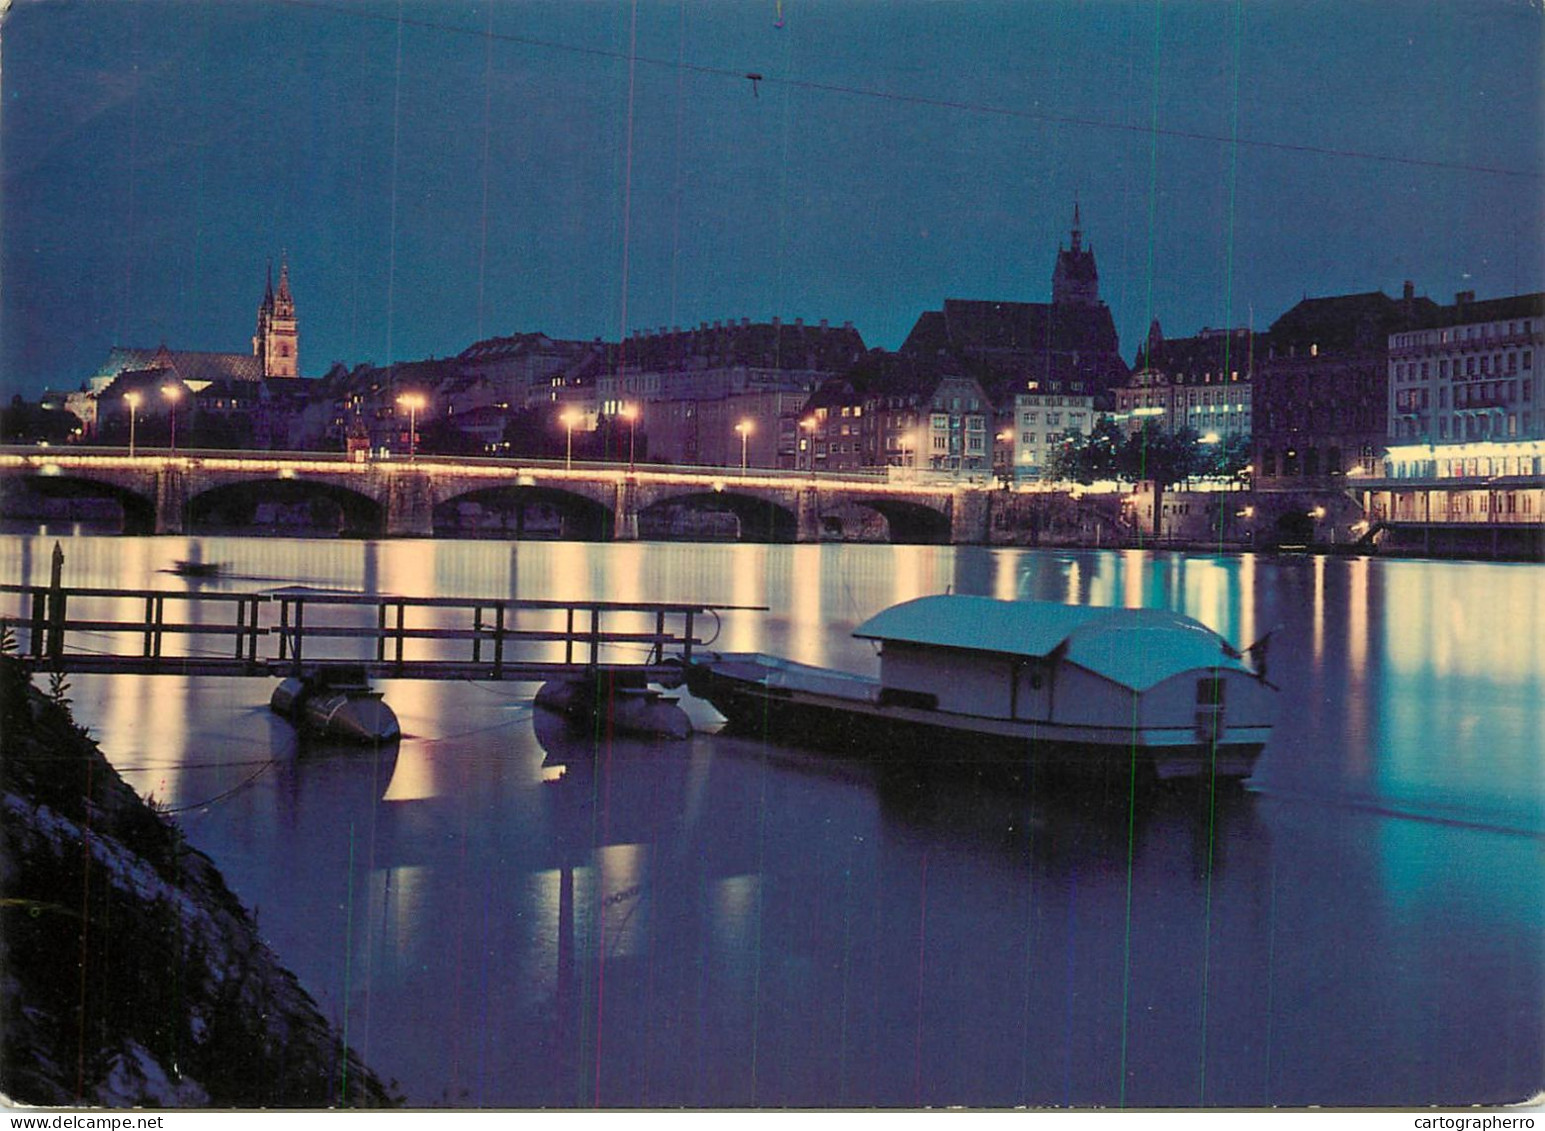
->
[185,476,385,538]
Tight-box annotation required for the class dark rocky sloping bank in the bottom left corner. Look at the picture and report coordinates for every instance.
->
[0,655,394,1108]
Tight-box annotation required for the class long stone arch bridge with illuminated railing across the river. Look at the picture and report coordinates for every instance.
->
[0,448,993,544]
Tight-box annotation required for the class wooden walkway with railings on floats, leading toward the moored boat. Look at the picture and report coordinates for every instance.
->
[0,584,749,683]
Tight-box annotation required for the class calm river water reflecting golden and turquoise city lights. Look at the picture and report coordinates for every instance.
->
[0,535,1545,1108]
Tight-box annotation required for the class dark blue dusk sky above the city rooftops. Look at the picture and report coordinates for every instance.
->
[0,0,1545,394]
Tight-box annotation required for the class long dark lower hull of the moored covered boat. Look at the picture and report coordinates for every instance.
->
[688,661,1270,780]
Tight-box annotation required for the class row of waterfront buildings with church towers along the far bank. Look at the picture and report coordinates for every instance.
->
[36,214,1545,487]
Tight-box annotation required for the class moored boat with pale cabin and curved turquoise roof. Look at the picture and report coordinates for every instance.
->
[688,596,1276,779]
